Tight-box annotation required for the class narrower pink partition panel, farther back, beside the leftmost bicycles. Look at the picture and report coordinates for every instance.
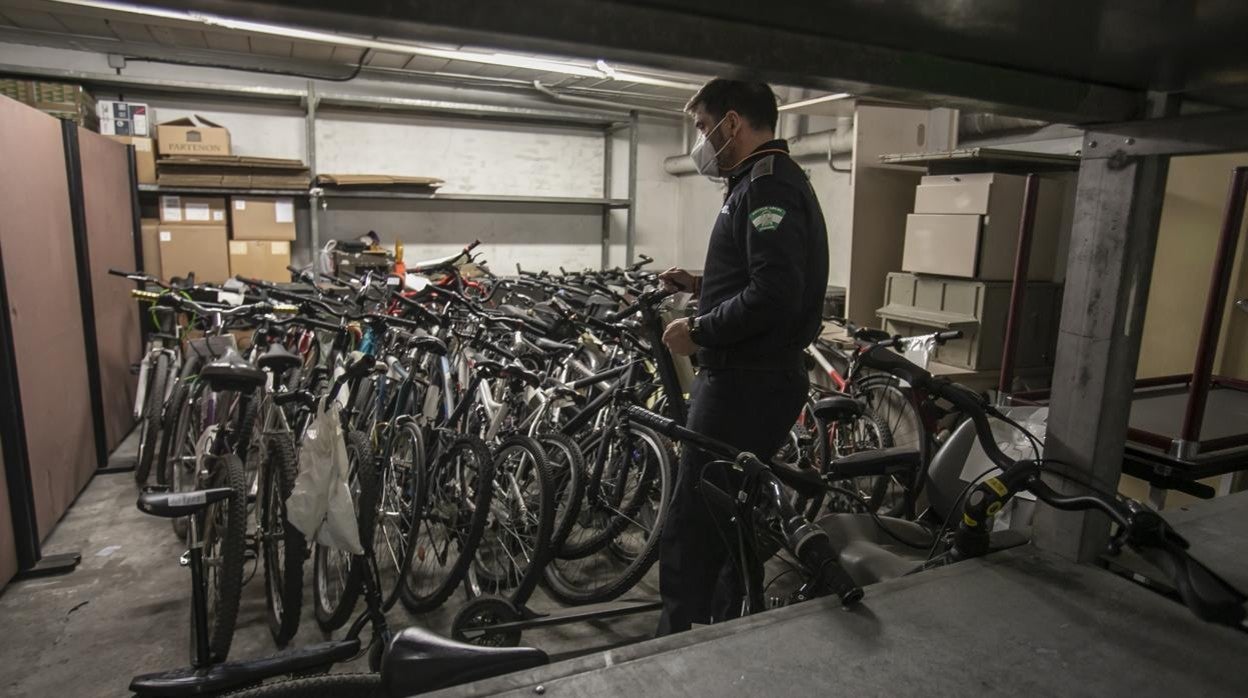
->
[79,129,142,452]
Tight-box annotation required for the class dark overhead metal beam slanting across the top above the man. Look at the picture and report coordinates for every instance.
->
[155,0,1143,122]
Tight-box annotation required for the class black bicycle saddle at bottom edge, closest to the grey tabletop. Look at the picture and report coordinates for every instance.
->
[382,628,550,698]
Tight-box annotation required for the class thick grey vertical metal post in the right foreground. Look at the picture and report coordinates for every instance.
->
[1035,105,1169,562]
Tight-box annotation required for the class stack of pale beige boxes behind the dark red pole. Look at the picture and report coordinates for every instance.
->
[876,172,1070,371]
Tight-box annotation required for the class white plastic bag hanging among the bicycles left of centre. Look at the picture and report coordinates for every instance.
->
[286,402,364,554]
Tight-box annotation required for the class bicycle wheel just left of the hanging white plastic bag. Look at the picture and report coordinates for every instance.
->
[260,433,307,647]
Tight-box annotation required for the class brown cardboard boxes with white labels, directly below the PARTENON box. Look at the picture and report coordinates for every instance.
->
[156,196,230,283]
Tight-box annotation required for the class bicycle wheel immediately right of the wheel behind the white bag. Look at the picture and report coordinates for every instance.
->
[373,422,424,611]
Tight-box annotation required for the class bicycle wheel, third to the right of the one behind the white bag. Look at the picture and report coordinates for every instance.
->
[468,435,554,603]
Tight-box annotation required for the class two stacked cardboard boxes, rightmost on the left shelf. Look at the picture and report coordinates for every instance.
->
[230,196,295,282]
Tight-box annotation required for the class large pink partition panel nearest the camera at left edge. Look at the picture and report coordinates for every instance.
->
[0,97,96,539]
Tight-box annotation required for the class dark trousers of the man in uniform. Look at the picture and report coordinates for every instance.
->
[658,367,809,636]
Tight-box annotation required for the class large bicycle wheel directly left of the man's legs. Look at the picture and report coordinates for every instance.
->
[543,425,675,604]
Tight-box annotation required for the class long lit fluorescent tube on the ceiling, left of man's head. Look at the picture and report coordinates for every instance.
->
[52,0,698,90]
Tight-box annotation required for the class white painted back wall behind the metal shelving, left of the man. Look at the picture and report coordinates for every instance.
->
[0,44,683,273]
